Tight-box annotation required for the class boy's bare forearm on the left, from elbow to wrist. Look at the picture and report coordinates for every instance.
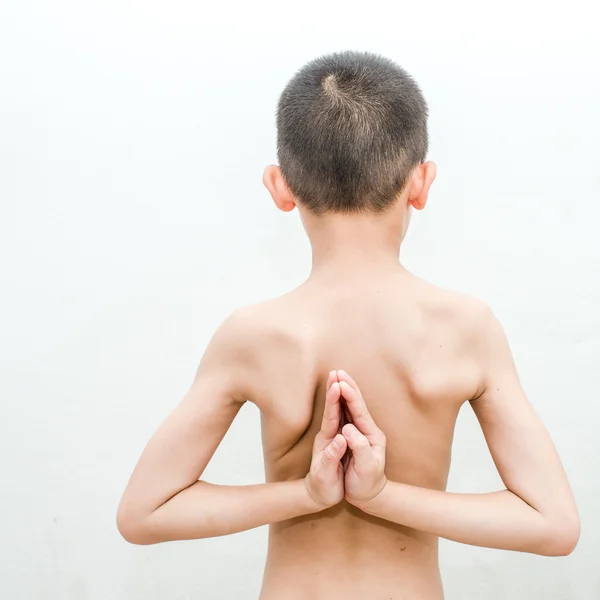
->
[119,479,320,544]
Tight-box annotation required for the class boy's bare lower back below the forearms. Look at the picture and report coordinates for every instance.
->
[260,503,443,600]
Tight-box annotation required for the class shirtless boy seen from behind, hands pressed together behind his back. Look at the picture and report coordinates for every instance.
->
[118,52,579,600]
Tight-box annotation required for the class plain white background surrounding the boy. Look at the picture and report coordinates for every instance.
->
[0,0,600,600]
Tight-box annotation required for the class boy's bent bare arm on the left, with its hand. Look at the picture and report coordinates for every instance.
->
[117,315,346,544]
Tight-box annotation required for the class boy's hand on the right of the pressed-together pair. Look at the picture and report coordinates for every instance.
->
[337,371,387,508]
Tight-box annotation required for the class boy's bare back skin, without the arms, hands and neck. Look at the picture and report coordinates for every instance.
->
[244,267,480,600]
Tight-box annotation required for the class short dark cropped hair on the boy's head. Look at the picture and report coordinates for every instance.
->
[277,51,428,214]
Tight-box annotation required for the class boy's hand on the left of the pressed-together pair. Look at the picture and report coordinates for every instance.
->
[304,371,347,510]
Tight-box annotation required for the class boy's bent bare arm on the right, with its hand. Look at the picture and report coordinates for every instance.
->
[342,310,579,555]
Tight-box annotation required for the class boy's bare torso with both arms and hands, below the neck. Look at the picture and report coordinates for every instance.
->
[117,259,580,600]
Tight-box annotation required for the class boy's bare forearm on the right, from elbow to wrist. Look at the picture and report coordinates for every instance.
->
[360,481,570,555]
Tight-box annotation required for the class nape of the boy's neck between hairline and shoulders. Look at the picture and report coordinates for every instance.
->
[303,211,404,279]
